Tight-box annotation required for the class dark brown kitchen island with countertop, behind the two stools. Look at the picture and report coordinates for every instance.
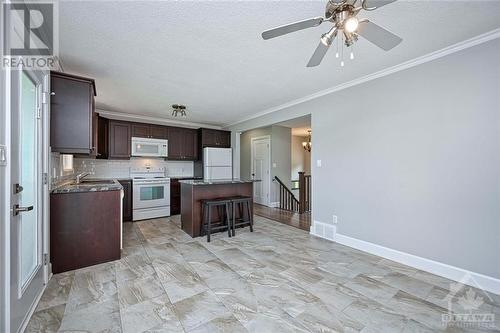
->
[179,179,255,237]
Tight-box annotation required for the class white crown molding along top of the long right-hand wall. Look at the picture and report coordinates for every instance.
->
[222,28,500,128]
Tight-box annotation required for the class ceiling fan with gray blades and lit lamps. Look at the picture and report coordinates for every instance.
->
[262,0,403,67]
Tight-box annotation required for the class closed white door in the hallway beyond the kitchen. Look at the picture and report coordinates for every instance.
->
[252,137,271,206]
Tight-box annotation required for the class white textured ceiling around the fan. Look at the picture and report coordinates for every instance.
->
[59,0,500,125]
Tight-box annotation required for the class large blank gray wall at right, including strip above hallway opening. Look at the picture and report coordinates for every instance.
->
[232,39,500,278]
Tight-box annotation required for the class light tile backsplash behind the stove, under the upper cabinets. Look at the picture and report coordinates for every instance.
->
[73,158,194,178]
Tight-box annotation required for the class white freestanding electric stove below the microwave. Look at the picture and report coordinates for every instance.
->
[130,167,170,221]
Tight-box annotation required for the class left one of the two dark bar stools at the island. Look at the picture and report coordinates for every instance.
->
[201,199,231,242]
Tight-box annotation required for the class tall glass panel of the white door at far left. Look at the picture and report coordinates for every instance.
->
[19,73,39,287]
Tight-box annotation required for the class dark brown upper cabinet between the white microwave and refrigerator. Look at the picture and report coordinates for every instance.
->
[168,127,198,161]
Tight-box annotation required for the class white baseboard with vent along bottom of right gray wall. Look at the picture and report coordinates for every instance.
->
[310,221,500,295]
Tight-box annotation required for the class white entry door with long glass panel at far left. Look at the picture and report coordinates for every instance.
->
[10,71,46,332]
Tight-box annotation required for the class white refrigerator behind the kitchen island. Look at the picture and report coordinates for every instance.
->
[203,148,233,181]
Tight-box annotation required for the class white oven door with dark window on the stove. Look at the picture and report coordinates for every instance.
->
[133,181,170,209]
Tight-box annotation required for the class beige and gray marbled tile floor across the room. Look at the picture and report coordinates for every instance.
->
[27,216,500,333]
